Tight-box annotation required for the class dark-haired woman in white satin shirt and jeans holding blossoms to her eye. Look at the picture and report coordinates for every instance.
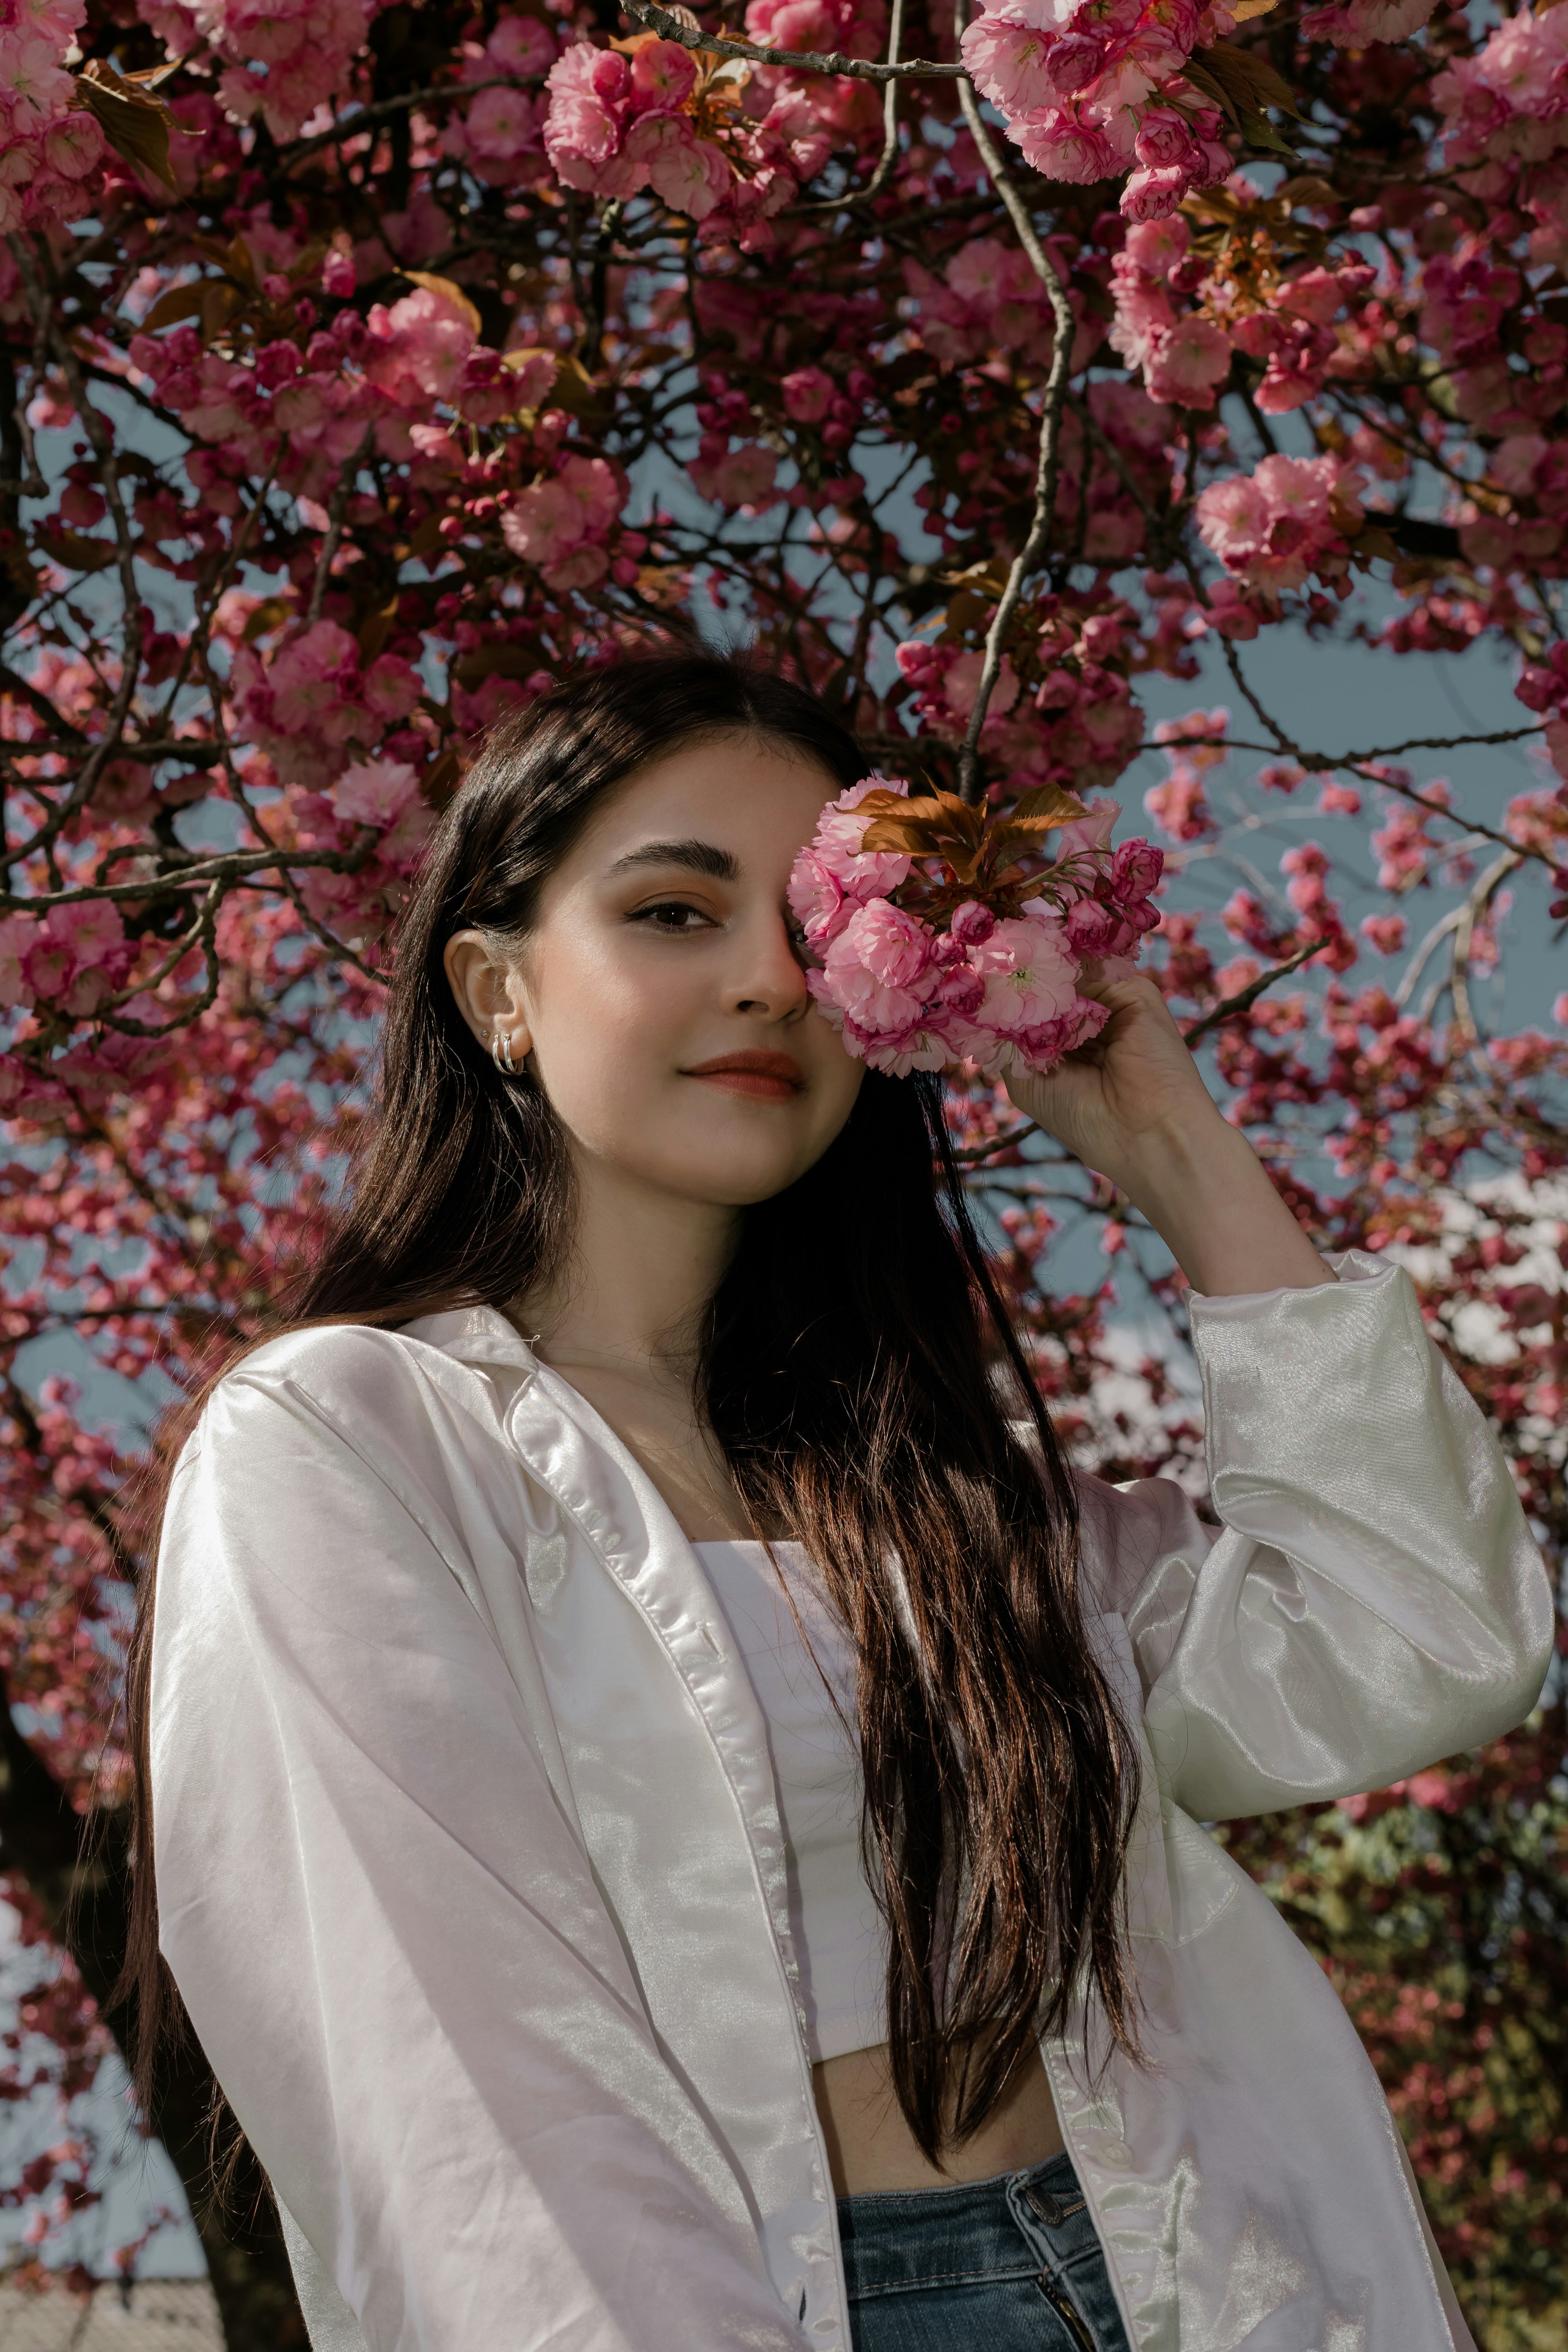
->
[136,656,1552,2352]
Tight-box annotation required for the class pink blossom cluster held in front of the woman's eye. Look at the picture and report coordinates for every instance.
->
[790,776,1164,1077]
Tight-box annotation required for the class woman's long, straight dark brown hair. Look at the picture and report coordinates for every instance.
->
[122,652,1138,2159]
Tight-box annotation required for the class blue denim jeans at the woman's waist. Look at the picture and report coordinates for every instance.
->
[839,2154,1128,2352]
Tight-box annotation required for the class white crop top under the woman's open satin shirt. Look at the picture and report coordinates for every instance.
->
[693,1543,886,2060]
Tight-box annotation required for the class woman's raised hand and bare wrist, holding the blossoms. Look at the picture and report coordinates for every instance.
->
[1008,971,1333,1296]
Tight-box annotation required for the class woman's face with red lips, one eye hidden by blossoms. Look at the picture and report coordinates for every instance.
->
[447,736,863,1207]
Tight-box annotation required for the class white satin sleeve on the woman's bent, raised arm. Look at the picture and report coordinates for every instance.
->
[1084,1251,1554,1820]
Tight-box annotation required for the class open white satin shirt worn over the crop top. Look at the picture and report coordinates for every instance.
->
[153,1254,1552,2352]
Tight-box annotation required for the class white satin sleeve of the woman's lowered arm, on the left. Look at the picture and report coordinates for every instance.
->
[153,1334,799,2352]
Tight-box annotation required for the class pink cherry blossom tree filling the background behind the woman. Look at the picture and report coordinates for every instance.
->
[0,0,1568,2352]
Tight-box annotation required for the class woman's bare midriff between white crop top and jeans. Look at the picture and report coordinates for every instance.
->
[811,2044,1063,2197]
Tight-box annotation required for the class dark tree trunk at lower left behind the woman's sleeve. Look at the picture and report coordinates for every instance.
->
[0,1679,306,2352]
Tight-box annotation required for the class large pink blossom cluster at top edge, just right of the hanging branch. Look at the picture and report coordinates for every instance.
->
[962,0,1232,221]
